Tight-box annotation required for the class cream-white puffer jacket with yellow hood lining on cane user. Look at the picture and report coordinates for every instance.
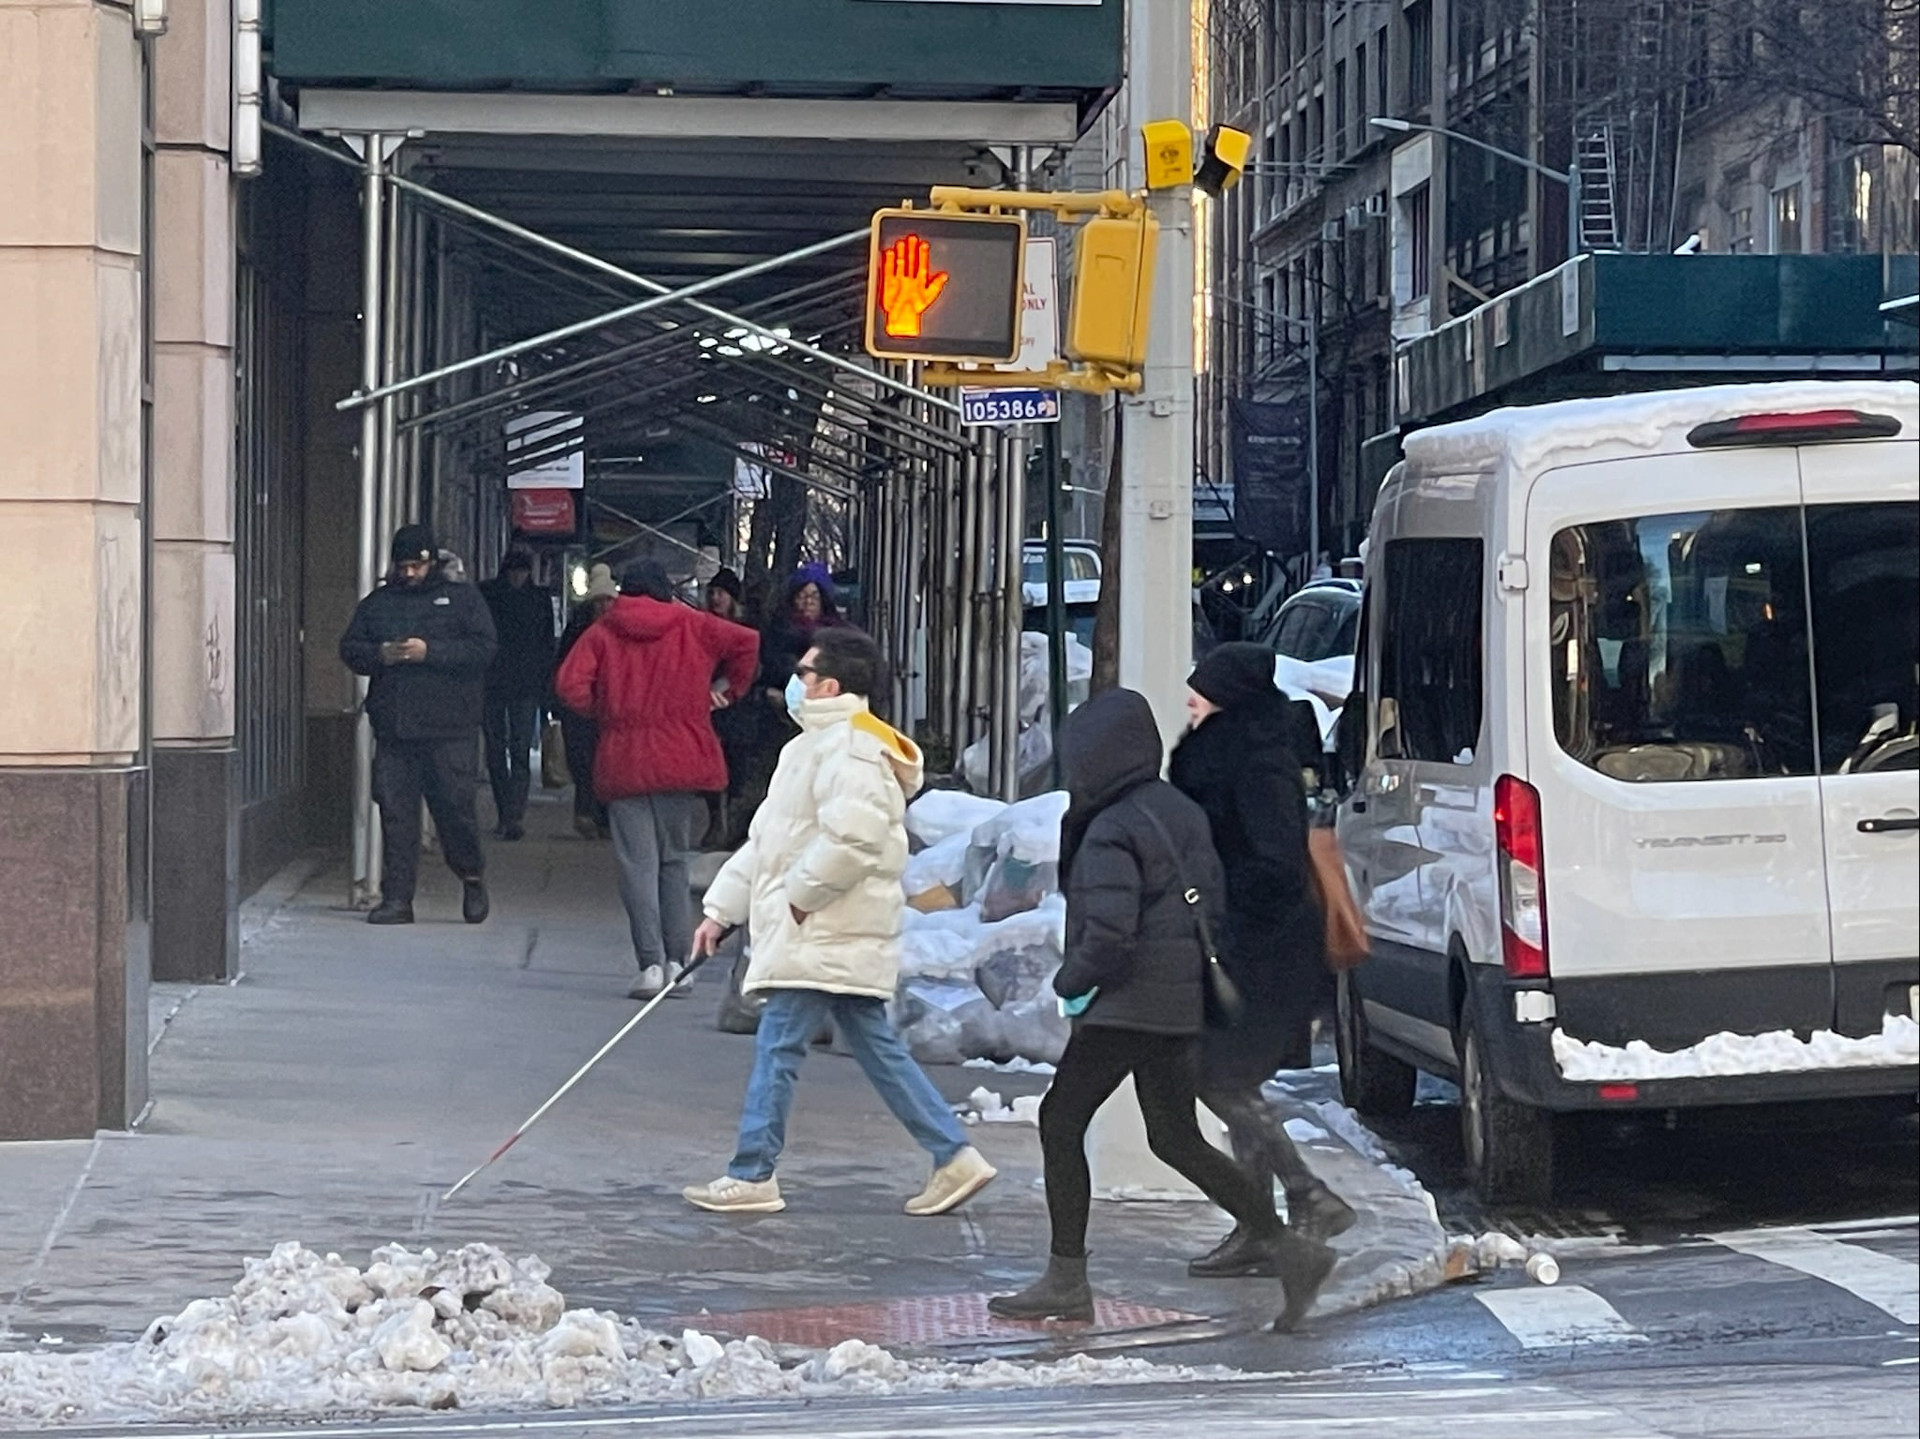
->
[707,695,922,999]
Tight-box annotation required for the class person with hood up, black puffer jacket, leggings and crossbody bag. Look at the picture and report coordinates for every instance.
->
[989,690,1325,1328]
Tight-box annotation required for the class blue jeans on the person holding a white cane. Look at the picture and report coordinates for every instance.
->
[726,989,968,1183]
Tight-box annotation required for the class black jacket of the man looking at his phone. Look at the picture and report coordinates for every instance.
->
[340,567,495,742]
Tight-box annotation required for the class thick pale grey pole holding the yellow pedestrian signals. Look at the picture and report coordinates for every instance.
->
[1106,0,1194,744]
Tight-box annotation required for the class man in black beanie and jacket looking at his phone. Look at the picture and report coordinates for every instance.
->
[340,524,493,924]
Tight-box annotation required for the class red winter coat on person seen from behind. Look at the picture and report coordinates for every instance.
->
[553,596,760,801]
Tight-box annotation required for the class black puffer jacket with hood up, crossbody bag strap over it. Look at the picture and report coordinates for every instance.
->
[1054,690,1225,1036]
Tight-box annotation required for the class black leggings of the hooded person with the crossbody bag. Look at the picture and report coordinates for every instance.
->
[1041,1024,1277,1258]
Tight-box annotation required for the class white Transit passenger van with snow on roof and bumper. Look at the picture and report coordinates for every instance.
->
[1336,380,1920,1199]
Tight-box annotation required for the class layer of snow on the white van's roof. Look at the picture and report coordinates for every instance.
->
[1405,380,1920,473]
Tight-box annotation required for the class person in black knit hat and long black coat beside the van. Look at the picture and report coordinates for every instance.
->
[1167,644,1354,1278]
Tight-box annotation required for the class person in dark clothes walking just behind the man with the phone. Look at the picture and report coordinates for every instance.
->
[480,549,553,840]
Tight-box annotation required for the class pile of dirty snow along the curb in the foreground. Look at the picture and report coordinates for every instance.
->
[0,1243,1235,1422]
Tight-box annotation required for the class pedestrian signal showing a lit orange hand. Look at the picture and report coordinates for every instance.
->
[866,209,1027,365]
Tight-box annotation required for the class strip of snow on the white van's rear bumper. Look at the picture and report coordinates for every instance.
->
[1553,1014,1920,1084]
